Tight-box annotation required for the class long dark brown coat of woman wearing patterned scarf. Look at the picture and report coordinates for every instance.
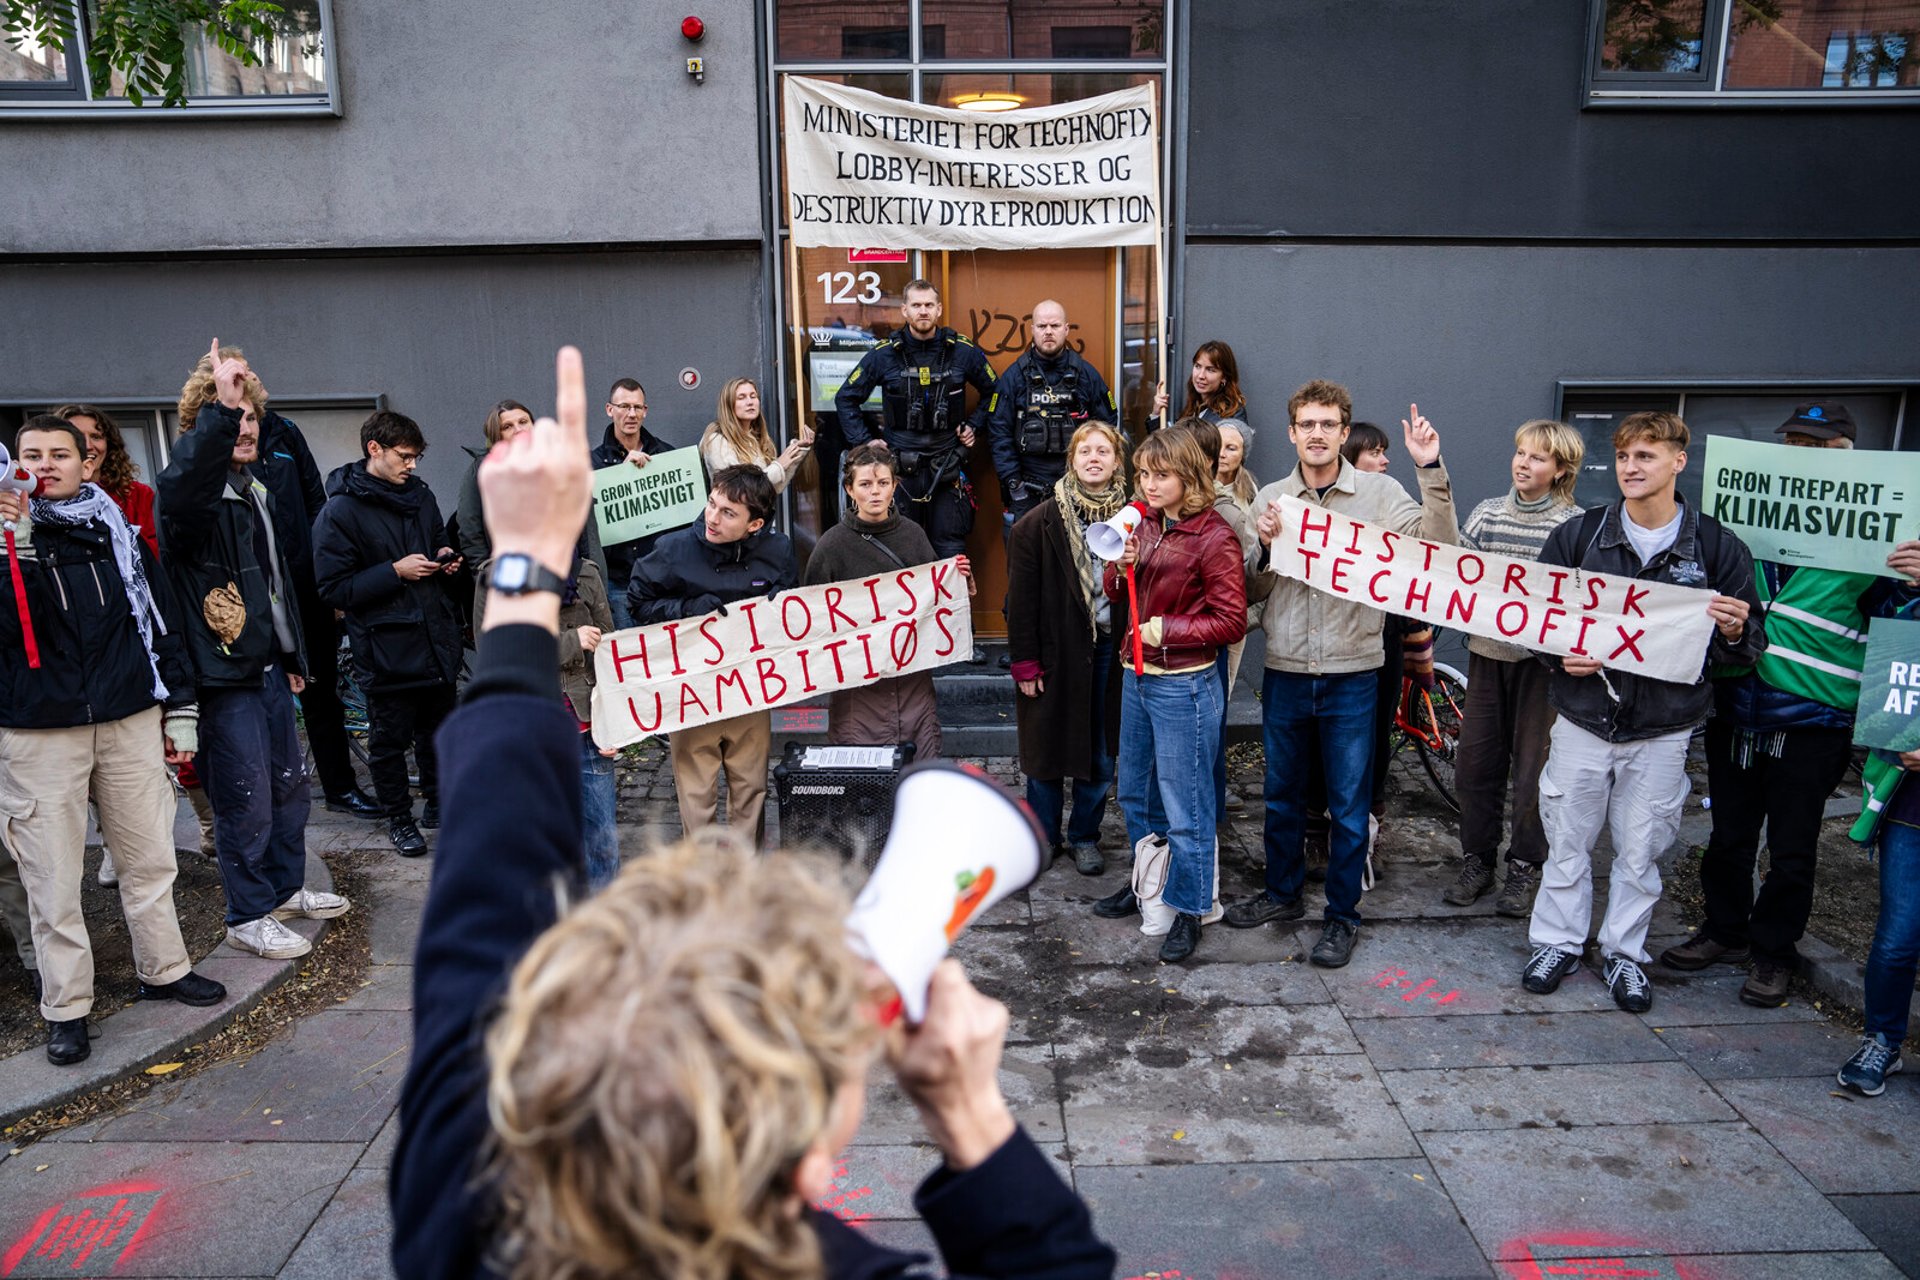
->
[1006,497,1127,779]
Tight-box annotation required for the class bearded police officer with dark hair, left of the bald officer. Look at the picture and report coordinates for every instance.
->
[833,280,993,558]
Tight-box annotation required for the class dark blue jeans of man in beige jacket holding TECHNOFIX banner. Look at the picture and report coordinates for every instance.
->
[1260,670,1379,925]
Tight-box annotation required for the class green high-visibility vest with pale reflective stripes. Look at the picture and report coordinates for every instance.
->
[1753,564,1874,712]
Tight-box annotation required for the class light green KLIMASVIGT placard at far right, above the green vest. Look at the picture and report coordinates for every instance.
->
[1701,436,1920,578]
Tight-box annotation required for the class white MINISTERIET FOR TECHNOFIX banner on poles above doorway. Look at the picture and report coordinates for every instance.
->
[785,75,1162,249]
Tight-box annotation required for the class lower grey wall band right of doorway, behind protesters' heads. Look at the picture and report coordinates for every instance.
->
[1185,244,1920,512]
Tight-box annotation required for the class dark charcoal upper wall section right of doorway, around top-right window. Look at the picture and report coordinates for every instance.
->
[1187,0,1920,240]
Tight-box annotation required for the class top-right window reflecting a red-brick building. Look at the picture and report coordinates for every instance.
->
[1588,0,1920,106]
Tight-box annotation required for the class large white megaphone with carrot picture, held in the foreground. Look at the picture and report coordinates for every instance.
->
[847,760,1046,1023]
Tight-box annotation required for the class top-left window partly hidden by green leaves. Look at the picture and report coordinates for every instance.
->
[0,0,338,119]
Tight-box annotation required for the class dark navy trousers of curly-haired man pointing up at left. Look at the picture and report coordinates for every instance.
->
[196,666,313,925]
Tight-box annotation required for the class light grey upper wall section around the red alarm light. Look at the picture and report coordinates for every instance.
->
[0,0,762,253]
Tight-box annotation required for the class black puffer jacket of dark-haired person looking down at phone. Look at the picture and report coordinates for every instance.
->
[313,459,465,689]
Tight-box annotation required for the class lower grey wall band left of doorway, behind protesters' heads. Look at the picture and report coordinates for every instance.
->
[0,249,770,498]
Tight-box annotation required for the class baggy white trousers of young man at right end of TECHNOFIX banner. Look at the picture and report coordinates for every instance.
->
[1526,716,1692,963]
